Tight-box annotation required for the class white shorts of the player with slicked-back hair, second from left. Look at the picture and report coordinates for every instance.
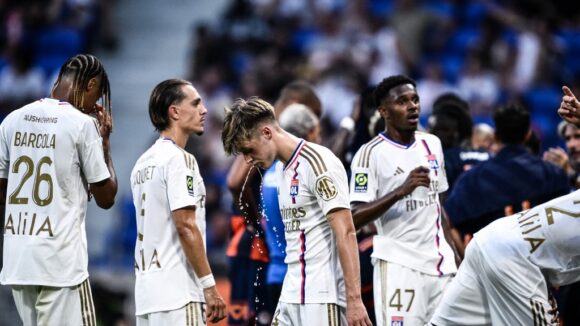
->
[137,302,206,326]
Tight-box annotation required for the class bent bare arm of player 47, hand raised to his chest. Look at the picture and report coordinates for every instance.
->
[351,166,430,229]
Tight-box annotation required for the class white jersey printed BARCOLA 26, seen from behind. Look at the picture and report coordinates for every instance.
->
[0,98,110,287]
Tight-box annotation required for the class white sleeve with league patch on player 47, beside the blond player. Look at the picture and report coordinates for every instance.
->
[350,145,378,203]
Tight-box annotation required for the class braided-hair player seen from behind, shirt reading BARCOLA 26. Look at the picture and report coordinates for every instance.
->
[0,54,117,325]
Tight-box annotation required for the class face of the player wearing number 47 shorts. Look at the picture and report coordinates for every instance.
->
[379,84,421,132]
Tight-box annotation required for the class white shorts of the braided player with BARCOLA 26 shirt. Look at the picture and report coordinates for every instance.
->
[11,279,97,326]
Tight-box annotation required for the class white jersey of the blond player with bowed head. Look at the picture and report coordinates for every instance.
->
[276,140,350,306]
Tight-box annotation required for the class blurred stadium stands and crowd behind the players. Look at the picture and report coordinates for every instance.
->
[0,0,580,325]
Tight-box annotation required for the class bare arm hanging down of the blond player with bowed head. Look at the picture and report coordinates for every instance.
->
[326,208,372,325]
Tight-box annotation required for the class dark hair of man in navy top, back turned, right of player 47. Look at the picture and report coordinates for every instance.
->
[493,105,530,144]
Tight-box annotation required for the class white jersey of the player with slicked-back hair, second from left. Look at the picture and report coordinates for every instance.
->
[131,138,205,315]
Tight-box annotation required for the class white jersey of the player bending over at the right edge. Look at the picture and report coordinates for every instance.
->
[474,190,580,286]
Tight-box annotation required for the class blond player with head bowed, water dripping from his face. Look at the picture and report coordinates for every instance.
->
[222,98,370,325]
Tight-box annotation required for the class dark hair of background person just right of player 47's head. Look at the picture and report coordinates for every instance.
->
[432,93,473,142]
